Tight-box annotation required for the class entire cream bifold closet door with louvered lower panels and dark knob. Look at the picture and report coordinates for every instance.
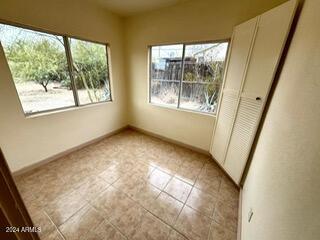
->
[211,0,297,184]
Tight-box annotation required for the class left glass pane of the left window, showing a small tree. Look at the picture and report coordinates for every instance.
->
[0,24,75,113]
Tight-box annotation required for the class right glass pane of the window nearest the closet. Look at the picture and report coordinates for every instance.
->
[180,42,228,112]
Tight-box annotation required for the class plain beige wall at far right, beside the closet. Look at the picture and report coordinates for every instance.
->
[242,0,320,240]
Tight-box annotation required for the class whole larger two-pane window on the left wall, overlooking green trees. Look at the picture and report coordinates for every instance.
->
[0,24,111,115]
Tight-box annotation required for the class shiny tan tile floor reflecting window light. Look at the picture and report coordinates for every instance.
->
[16,130,239,240]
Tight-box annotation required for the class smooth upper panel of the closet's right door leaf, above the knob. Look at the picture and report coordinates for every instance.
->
[243,1,295,97]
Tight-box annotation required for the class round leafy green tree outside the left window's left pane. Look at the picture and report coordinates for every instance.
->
[7,39,66,92]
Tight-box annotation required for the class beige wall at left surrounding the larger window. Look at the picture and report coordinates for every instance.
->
[0,0,127,171]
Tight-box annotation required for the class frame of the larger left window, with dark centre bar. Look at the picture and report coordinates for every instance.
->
[0,18,113,117]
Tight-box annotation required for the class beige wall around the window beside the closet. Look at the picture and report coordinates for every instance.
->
[125,0,284,151]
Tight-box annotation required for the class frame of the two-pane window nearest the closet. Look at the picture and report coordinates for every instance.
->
[148,38,231,116]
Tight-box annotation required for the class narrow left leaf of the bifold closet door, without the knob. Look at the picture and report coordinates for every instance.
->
[211,18,258,165]
